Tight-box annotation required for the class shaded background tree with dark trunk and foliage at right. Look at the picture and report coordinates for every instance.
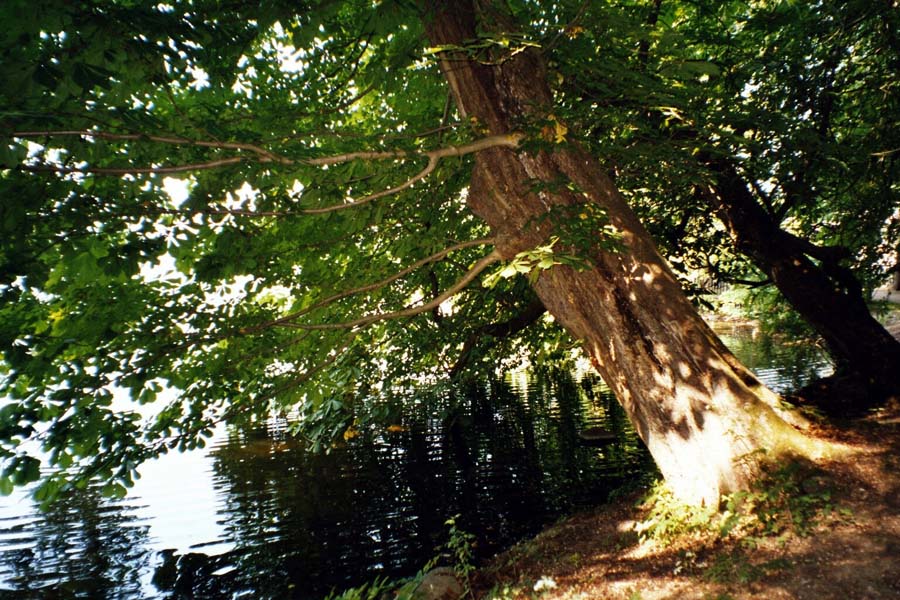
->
[556,0,900,411]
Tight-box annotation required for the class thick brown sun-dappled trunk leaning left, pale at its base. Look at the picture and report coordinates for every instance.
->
[425,0,821,503]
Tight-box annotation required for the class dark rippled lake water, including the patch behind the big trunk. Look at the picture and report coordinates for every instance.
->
[0,331,827,599]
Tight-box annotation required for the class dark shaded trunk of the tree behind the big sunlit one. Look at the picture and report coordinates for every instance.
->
[707,160,900,413]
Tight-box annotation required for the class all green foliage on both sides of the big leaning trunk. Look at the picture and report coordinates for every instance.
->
[0,0,900,498]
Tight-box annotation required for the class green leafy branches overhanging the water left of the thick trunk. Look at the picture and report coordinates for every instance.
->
[0,1,576,499]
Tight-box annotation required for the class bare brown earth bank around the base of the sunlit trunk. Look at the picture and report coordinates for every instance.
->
[474,396,900,600]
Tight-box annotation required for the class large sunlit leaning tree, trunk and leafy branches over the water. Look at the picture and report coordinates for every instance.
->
[0,0,825,502]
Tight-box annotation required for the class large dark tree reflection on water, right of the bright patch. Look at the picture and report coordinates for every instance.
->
[160,374,649,598]
